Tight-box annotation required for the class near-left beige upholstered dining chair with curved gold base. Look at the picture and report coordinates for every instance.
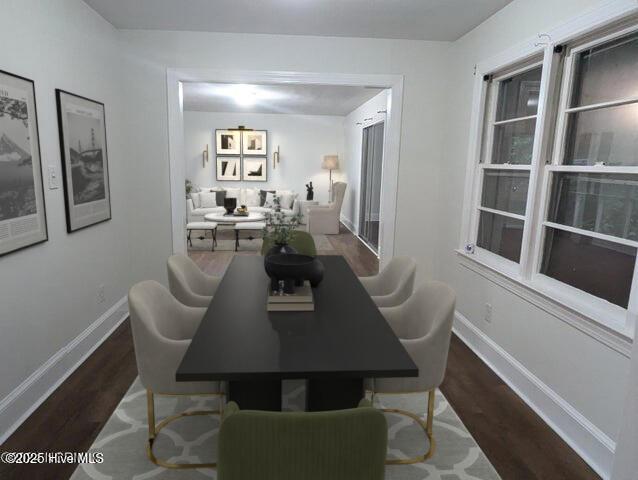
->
[128,280,223,468]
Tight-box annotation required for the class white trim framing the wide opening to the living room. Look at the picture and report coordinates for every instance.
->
[166,67,403,263]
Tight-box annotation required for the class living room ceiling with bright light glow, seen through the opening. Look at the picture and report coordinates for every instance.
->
[183,83,382,116]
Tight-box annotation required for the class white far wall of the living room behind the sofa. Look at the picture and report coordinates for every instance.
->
[184,111,344,203]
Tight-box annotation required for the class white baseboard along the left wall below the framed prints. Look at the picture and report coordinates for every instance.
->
[0,297,128,444]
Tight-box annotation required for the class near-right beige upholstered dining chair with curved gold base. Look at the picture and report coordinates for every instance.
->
[366,282,456,465]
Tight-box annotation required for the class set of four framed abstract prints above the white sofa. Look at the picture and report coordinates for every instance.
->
[215,128,268,182]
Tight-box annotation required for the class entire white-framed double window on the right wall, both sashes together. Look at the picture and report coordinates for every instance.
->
[464,21,638,330]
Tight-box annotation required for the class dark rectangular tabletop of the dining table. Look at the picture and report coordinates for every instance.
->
[176,255,418,381]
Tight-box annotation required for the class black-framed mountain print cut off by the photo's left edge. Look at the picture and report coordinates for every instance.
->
[0,71,48,255]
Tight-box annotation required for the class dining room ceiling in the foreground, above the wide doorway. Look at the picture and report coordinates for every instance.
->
[84,0,511,41]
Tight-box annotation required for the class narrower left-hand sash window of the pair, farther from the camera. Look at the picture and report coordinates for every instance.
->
[476,62,542,263]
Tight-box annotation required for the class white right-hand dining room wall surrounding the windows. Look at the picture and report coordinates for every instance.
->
[434,0,629,473]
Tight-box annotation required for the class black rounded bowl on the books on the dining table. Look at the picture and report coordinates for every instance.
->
[264,253,323,294]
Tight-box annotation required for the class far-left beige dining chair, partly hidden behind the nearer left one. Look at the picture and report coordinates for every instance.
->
[168,255,221,307]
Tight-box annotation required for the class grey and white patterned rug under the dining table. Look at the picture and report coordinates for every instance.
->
[71,378,500,480]
